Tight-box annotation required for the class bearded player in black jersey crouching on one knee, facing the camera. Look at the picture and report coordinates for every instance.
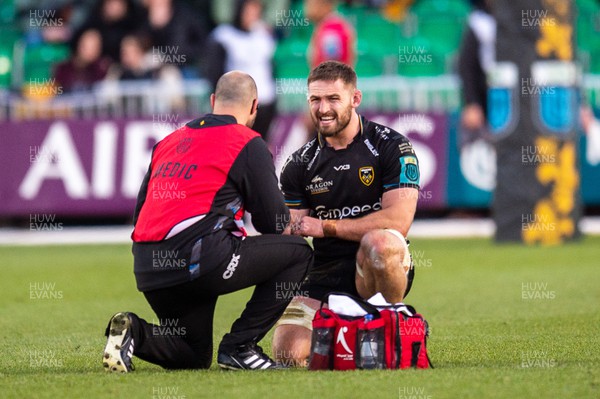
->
[273,61,419,365]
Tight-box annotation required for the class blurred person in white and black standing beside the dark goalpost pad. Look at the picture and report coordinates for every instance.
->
[458,0,496,134]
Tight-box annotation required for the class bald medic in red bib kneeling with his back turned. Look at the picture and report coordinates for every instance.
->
[102,71,312,372]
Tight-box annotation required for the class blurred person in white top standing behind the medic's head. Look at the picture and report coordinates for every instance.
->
[206,0,276,141]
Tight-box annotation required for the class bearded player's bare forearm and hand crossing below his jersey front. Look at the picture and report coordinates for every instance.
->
[295,188,419,241]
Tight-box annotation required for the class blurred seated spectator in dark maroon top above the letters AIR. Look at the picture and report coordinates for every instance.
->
[54,29,110,92]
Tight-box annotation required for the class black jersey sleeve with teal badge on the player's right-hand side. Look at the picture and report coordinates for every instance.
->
[381,134,421,191]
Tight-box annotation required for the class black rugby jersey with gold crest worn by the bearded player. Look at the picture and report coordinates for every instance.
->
[281,116,420,263]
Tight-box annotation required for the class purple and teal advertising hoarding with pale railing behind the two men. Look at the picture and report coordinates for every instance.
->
[0,77,600,217]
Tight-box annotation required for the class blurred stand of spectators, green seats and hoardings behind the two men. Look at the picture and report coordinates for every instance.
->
[0,0,600,230]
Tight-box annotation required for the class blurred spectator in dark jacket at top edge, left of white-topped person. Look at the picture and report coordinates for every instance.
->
[144,0,210,75]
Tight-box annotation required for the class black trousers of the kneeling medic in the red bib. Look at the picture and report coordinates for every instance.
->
[124,235,313,369]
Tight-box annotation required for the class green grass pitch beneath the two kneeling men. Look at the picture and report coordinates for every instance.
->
[0,237,600,399]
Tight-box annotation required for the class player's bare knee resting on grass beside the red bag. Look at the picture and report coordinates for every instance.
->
[273,324,311,367]
